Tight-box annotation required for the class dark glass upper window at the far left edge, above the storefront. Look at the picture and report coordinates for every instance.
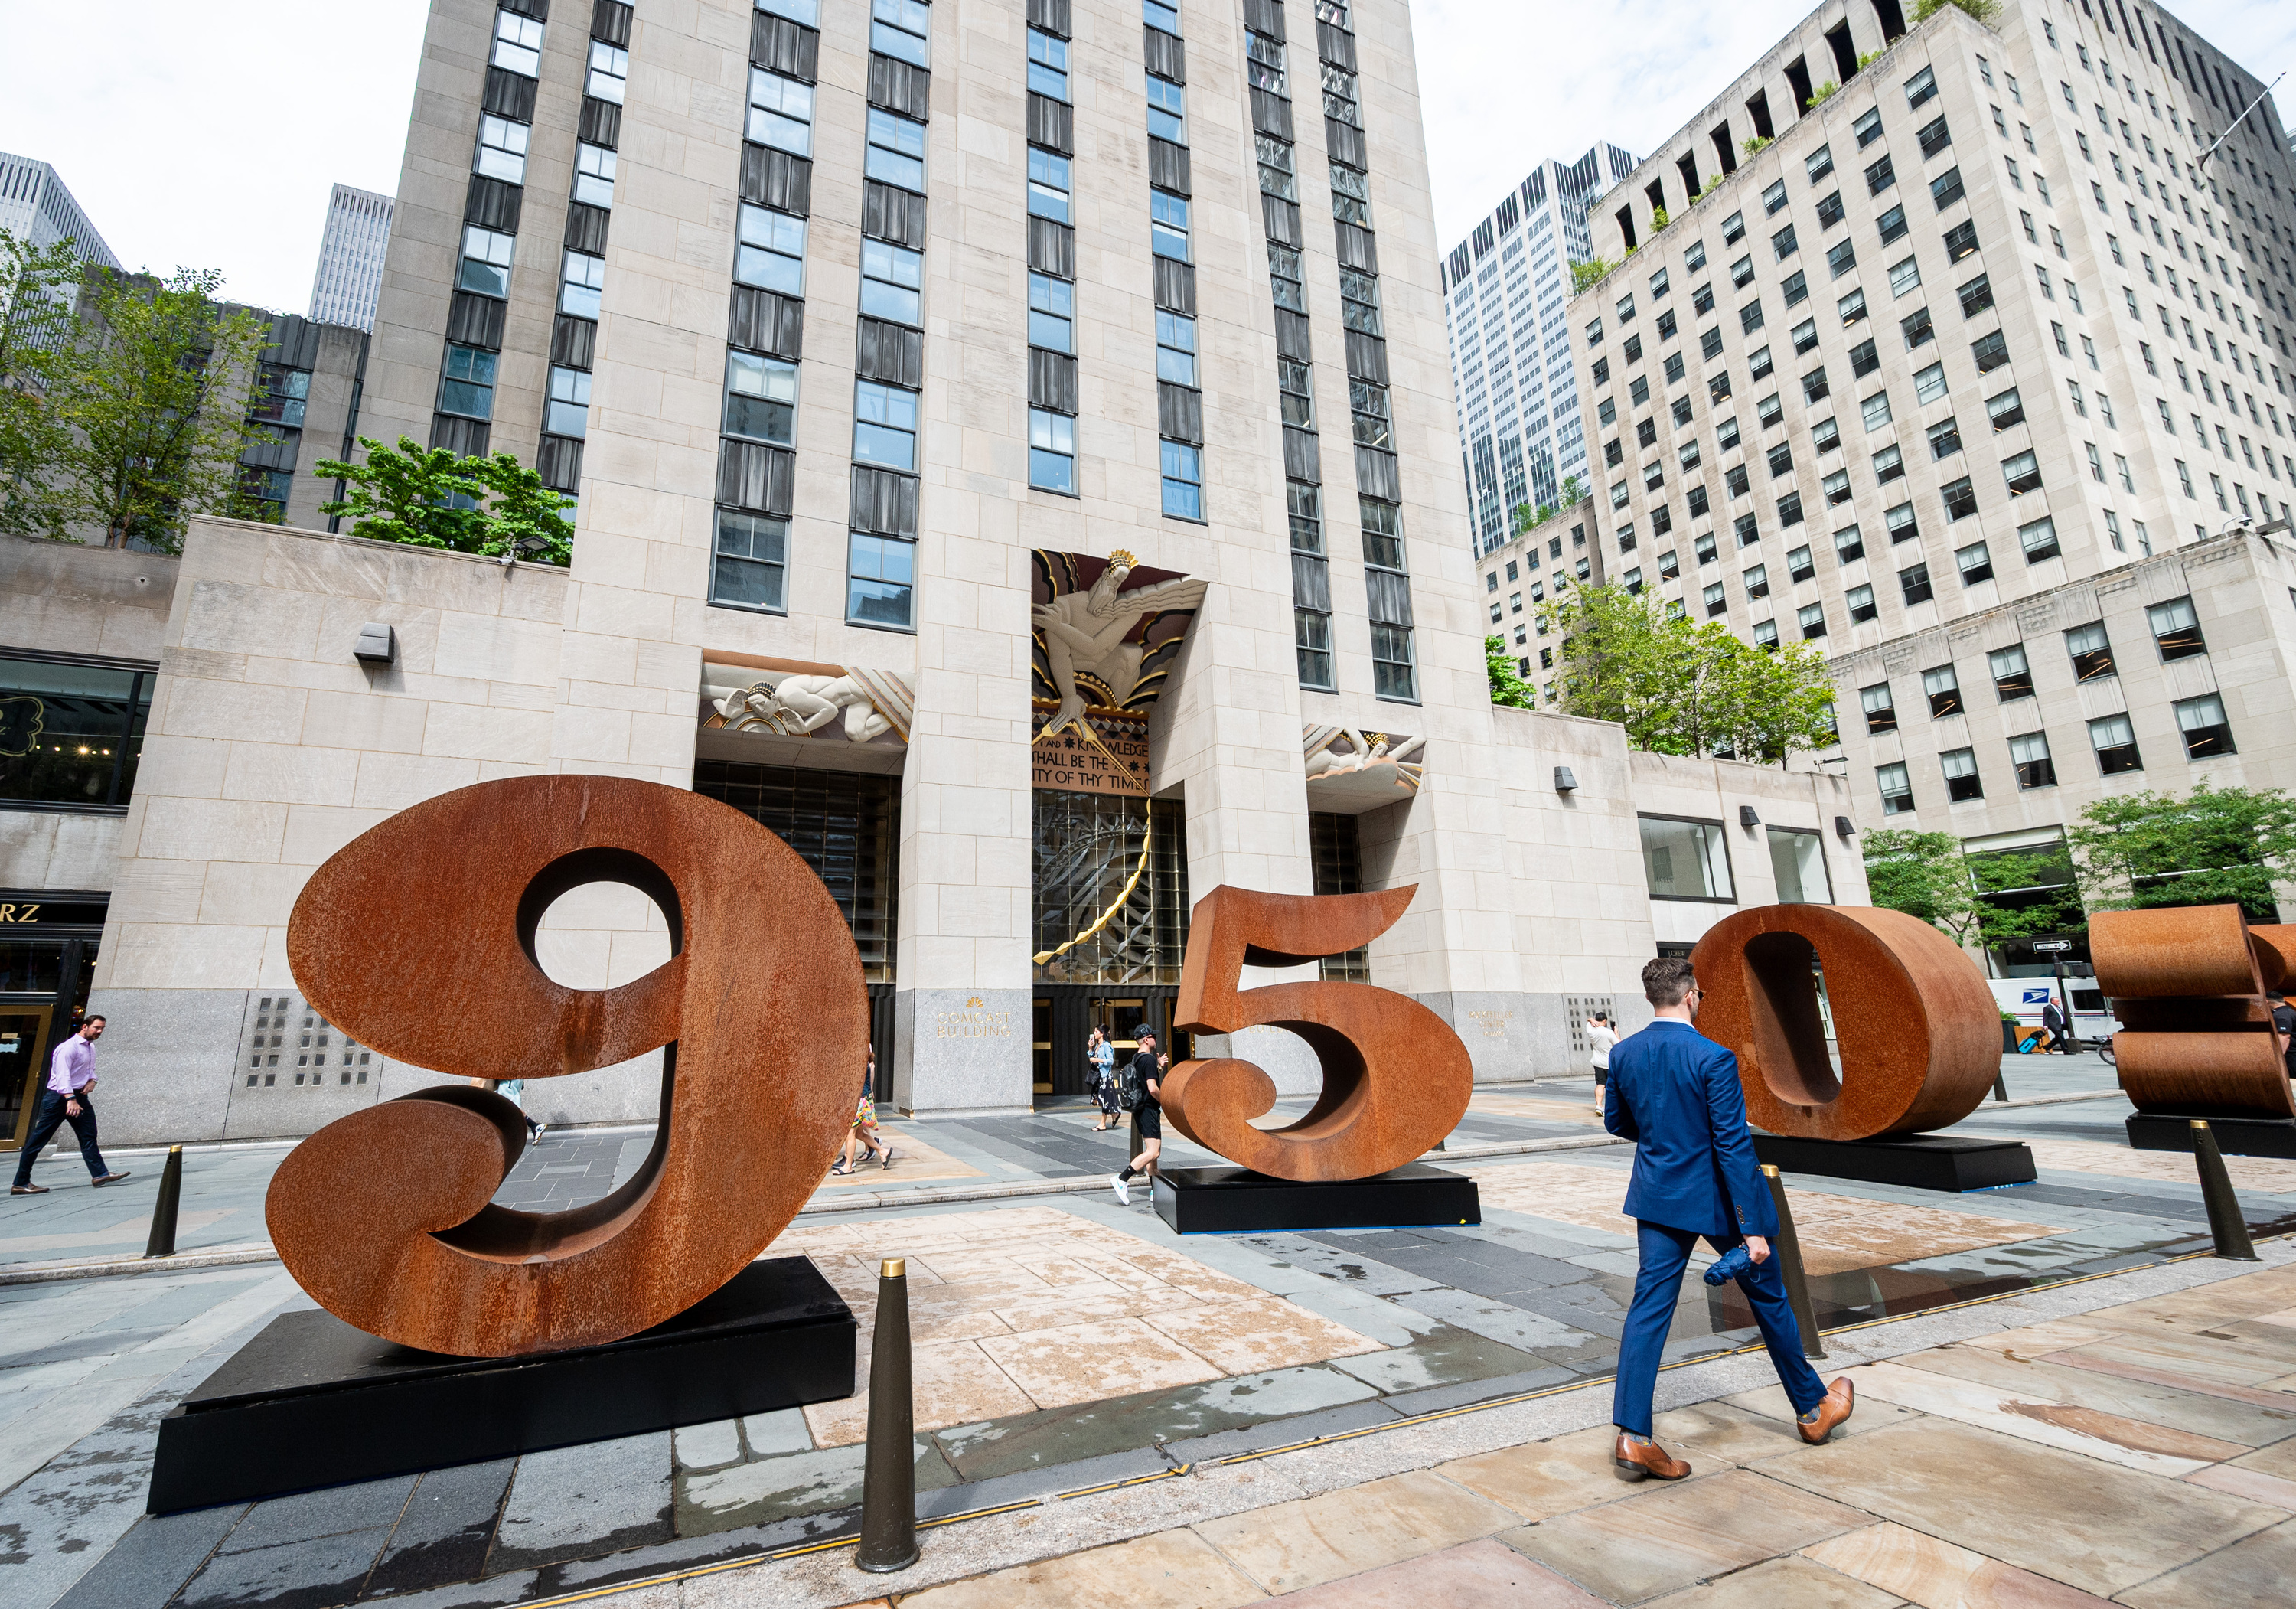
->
[0,654,154,810]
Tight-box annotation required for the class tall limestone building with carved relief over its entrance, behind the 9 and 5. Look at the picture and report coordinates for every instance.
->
[0,0,1862,1157]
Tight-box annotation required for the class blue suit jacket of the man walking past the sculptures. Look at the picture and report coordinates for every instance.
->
[1603,1017,1777,1242]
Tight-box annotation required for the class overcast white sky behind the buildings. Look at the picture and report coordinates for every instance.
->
[0,0,2296,312]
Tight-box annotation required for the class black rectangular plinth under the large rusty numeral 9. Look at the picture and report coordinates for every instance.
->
[145,1258,856,1515]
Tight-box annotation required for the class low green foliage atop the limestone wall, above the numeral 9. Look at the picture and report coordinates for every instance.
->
[315,436,574,565]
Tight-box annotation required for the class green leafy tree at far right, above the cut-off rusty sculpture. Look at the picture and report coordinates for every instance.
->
[2066,781,2296,922]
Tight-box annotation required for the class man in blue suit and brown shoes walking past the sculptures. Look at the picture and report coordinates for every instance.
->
[1603,955,1855,1480]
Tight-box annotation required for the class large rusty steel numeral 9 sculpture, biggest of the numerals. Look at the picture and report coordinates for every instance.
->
[264,776,868,1356]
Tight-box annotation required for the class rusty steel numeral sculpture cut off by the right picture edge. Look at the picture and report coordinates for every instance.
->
[2089,904,2296,1118]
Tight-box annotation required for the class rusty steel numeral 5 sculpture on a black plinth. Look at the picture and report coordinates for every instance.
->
[1159,883,1474,1182]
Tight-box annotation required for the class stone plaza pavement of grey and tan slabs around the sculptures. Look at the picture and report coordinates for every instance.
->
[0,1056,2296,1609]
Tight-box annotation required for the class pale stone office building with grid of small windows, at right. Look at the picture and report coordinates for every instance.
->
[1570,0,2296,966]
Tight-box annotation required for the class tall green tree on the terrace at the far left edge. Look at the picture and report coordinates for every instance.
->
[11,269,269,553]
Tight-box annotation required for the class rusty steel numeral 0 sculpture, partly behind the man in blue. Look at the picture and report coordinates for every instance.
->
[1690,904,2002,1141]
